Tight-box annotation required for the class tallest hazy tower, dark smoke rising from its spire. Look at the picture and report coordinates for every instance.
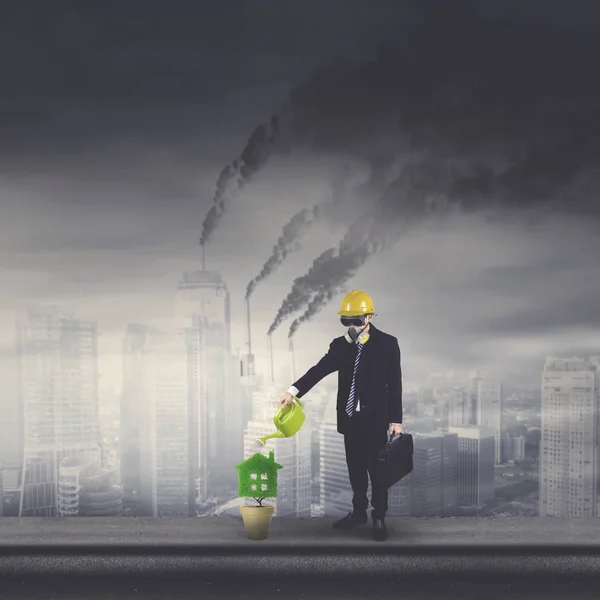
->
[175,271,239,501]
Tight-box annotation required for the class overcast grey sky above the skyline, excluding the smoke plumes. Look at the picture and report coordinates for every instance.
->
[0,0,600,394]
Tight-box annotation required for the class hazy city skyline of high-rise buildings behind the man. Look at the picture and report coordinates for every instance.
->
[0,270,600,517]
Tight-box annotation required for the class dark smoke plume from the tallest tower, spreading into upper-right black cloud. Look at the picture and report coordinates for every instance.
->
[201,0,600,255]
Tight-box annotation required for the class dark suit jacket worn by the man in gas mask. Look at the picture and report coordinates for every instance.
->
[293,323,402,433]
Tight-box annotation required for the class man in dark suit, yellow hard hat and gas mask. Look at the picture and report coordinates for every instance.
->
[281,290,402,541]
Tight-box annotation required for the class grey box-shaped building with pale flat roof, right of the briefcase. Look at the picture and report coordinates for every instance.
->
[449,425,496,508]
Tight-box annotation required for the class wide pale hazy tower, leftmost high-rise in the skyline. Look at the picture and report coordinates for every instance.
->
[18,307,100,516]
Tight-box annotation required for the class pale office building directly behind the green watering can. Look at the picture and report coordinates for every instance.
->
[244,382,311,517]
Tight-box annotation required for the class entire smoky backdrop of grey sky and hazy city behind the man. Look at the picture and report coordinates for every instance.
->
[0,0,600,524]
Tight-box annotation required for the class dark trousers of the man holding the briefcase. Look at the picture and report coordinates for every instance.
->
[344,411,388,519]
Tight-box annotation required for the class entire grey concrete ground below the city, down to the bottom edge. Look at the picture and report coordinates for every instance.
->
[0,517,600,600]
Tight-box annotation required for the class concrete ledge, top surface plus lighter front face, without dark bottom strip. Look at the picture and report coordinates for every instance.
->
[0,517,600,581]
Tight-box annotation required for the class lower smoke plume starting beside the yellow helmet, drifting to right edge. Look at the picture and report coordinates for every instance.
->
[280,131,600,339]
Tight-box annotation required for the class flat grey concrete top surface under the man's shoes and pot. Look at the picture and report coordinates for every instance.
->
[0,517,600,556]
